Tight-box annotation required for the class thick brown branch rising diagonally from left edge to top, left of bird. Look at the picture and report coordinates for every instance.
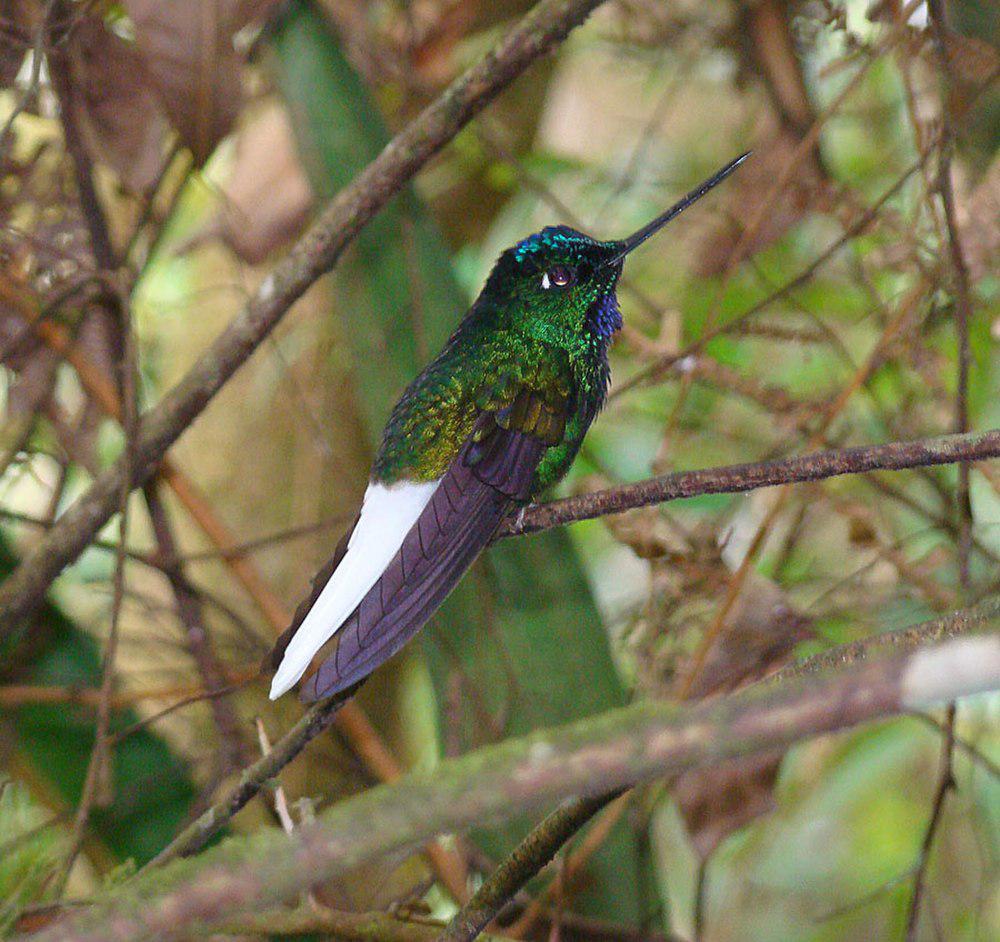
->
[0,0,602,637]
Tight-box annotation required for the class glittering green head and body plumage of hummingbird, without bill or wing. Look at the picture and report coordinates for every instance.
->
[372,227,621,488]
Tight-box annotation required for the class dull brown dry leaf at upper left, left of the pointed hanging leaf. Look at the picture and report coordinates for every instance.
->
[69,16,169,193]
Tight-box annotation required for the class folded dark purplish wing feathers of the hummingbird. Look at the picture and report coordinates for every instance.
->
[301,414,551,700]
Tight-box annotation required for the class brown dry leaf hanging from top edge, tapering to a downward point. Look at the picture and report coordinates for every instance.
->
[125,0,269,166]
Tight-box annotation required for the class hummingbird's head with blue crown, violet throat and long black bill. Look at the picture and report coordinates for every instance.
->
[480,153,749,345]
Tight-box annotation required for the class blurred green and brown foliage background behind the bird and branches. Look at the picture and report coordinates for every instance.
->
[0,0,1000,942]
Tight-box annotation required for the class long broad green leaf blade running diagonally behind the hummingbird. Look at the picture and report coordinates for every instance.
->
[273,0,640,922]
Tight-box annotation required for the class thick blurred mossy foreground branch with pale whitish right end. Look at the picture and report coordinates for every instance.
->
[34,608,1000,942]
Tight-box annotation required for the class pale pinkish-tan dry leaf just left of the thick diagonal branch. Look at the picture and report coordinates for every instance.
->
[184,102,313,265]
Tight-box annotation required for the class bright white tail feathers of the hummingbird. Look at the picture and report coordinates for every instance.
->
[271,481,438,700]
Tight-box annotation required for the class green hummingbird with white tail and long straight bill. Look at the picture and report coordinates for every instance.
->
[270,152,750,701]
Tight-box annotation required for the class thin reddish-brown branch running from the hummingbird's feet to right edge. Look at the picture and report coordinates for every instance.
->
[499,429,1000,538]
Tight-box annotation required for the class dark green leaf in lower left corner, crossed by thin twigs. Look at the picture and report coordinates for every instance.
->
[0,537,197,865]
